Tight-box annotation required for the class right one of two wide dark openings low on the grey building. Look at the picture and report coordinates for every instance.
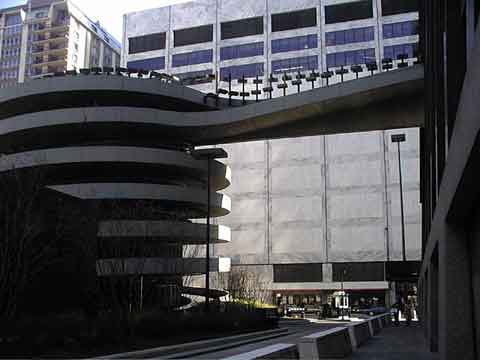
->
[332,262,385,282]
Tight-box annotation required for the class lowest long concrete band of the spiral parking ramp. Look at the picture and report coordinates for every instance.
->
[97,258,230,276]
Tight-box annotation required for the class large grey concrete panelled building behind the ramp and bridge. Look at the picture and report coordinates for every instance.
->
[122,0,421,306]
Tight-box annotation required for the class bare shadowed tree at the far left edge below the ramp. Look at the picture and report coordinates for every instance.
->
[0,168,55,322]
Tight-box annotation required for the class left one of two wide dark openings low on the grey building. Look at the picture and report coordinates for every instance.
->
[273,264,323,283]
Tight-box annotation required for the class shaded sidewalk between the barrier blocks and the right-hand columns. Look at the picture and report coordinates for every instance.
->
[349,322,439,360]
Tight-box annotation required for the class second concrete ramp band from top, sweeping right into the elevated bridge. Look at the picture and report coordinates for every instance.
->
[0,65,423,145]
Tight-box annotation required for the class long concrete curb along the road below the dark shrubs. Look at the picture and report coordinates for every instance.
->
[89,329,288,359]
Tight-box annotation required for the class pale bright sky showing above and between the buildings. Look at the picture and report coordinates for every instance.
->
[0,0,192,42]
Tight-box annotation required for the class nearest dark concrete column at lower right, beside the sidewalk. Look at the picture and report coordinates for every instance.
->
[438,223,475,360]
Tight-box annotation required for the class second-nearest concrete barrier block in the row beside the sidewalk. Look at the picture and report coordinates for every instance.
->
[298,327,353,359]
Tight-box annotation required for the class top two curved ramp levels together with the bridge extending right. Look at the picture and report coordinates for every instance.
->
[0,65,423,145]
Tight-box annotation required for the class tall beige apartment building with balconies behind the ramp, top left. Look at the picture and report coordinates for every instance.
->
[0,0,120,87]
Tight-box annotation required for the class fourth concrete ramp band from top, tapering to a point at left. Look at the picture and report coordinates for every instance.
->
[49,183,231,218]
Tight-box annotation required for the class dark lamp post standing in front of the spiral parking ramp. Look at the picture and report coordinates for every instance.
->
[190,148,228,312]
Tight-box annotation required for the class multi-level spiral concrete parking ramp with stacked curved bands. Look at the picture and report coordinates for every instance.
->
[0,77,231,307]
